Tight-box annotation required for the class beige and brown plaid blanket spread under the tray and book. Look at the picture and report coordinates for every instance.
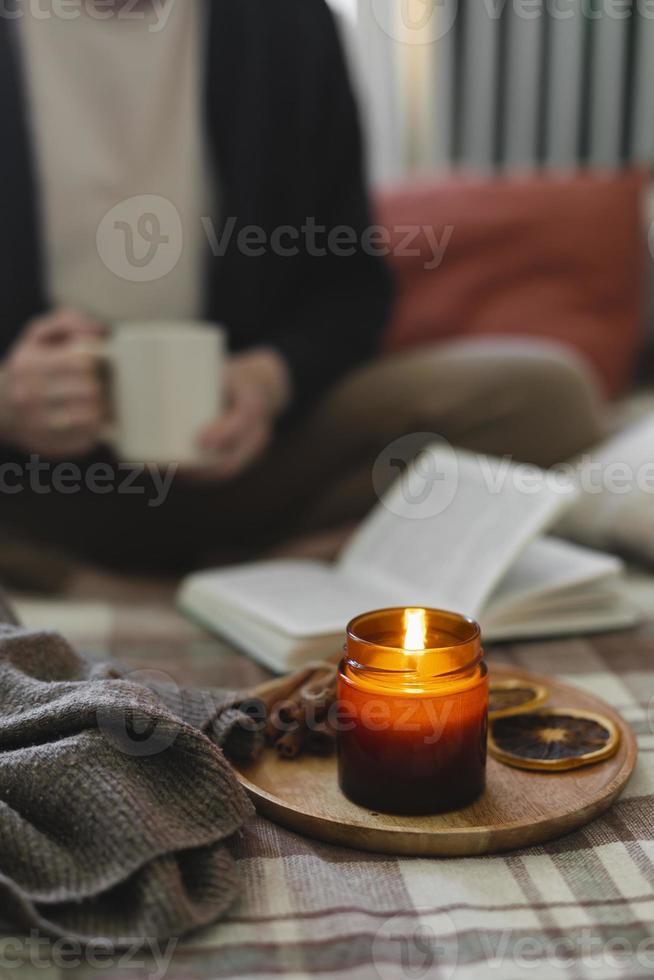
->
[7,605,654,980]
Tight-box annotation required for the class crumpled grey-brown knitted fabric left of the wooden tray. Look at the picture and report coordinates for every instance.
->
[0,600,261,947]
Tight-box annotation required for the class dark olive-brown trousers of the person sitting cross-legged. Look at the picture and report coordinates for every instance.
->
[0,338,603,589]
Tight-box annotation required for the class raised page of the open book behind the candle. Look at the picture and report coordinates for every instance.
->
[340,444,575,616]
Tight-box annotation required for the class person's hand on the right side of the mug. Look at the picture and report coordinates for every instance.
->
[195,348,291,480]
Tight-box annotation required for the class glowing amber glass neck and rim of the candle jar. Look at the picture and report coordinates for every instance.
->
[341,606,485,691]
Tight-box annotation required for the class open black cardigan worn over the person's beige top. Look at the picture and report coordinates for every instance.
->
[0,0,392,406]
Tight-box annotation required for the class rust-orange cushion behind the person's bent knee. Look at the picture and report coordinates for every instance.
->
[378,172,646,395]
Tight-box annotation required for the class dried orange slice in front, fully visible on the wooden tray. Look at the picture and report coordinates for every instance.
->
[488,708,620,772]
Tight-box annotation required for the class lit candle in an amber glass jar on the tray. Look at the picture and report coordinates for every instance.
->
[338,609,488,815]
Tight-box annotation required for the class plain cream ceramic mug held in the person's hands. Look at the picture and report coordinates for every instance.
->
[92,321,226,465]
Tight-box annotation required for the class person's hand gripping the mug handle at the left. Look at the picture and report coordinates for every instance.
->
[0,310,106,459]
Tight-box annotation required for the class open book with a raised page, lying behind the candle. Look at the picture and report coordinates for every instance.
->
[179,445,635,671]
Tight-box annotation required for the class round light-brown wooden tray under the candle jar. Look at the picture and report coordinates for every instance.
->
[237,666,638,857]
